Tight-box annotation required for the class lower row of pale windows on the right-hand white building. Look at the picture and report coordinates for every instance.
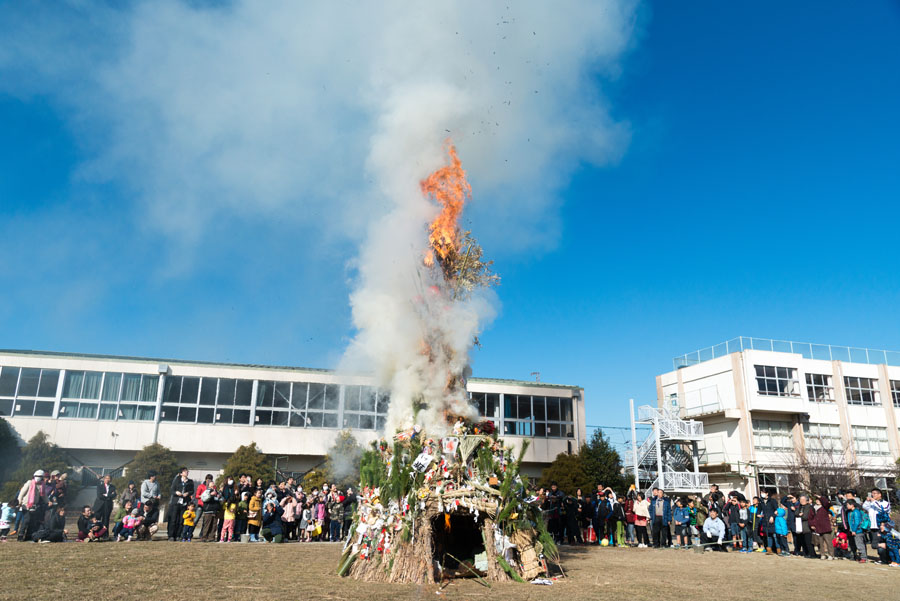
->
[753,419,890,456]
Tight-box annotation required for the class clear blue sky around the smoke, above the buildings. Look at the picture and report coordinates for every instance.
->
[0,1,900,442]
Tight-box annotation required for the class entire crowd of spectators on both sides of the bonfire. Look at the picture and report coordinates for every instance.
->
[0,468,900,566]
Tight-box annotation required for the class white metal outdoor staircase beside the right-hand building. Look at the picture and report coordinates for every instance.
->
[626,401,709,493]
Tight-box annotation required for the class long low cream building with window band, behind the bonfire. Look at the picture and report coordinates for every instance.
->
[0,350,585,475]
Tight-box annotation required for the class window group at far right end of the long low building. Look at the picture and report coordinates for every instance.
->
[503,394,575,438]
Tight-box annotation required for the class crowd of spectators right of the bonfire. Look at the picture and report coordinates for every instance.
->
[536,483,900,567]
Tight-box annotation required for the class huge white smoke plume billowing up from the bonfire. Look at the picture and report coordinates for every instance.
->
[0,0,637,426]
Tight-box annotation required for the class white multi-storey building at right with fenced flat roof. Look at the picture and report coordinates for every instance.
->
[656,337,900,494]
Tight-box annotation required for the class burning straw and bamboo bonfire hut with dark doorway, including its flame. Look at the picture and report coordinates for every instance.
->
[338,144,559,584]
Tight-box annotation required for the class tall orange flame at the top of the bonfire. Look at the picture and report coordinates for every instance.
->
[419,138,472,267]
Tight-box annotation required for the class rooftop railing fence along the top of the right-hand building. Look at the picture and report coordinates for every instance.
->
[673,336,900,369]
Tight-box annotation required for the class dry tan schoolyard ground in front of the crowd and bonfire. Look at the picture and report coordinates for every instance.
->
[0,542,900,601]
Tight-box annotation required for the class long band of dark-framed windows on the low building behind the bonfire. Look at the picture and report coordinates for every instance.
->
[0,367,575,438]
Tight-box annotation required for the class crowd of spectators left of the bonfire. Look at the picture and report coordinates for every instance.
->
[0,468,356,543]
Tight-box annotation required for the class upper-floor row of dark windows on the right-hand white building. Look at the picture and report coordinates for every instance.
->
[754,365,900,407]
